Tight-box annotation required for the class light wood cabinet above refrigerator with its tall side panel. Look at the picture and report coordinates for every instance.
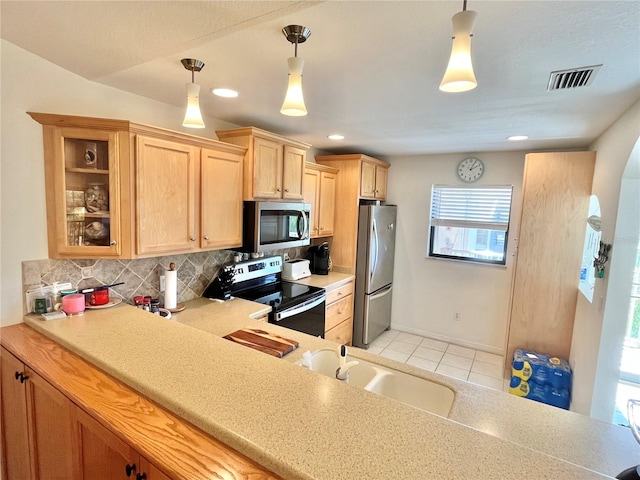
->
[315,154,389,273]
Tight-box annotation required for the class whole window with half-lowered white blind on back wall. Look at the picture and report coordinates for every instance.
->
[428,185,513,265]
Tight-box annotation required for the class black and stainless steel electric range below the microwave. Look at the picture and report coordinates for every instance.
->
[203,257,327,338]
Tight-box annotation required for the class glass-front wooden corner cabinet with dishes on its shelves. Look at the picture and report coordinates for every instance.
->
[30,113,130,258]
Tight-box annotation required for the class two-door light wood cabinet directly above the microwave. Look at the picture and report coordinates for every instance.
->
[216,127,311,201]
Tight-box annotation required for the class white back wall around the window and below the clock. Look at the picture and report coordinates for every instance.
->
[388,152,525,354]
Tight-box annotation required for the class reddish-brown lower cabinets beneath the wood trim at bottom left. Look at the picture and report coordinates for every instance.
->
[0,348,179,480]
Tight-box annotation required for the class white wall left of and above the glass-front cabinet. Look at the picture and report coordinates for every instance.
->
[0,40,245,326]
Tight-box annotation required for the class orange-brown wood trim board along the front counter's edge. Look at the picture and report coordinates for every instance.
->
[0,323,280,480]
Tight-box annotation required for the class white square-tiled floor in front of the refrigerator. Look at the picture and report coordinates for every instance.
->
[367,330,508,390]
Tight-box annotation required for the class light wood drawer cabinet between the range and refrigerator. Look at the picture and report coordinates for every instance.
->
[324,280,353,345]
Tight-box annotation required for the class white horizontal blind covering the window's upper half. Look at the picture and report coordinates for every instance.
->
[431,185,513,232]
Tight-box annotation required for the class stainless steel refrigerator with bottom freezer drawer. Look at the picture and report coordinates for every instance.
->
[352,205,397,348]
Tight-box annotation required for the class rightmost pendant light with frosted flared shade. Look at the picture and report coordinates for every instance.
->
[440,0,478,92]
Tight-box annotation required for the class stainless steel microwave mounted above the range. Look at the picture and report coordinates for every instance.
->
[242,202,311,252]
